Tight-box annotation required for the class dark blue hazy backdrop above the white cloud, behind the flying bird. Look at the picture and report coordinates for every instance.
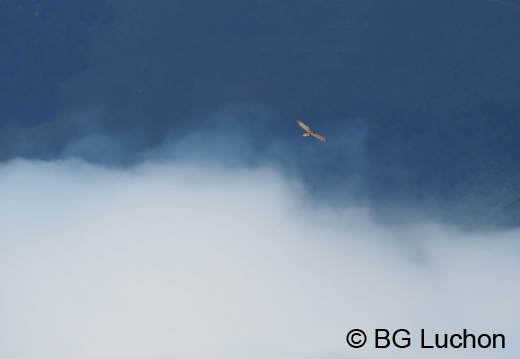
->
[0,0,520,228]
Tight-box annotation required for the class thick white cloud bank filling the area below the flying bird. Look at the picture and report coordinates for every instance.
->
[0,160,520,359]
